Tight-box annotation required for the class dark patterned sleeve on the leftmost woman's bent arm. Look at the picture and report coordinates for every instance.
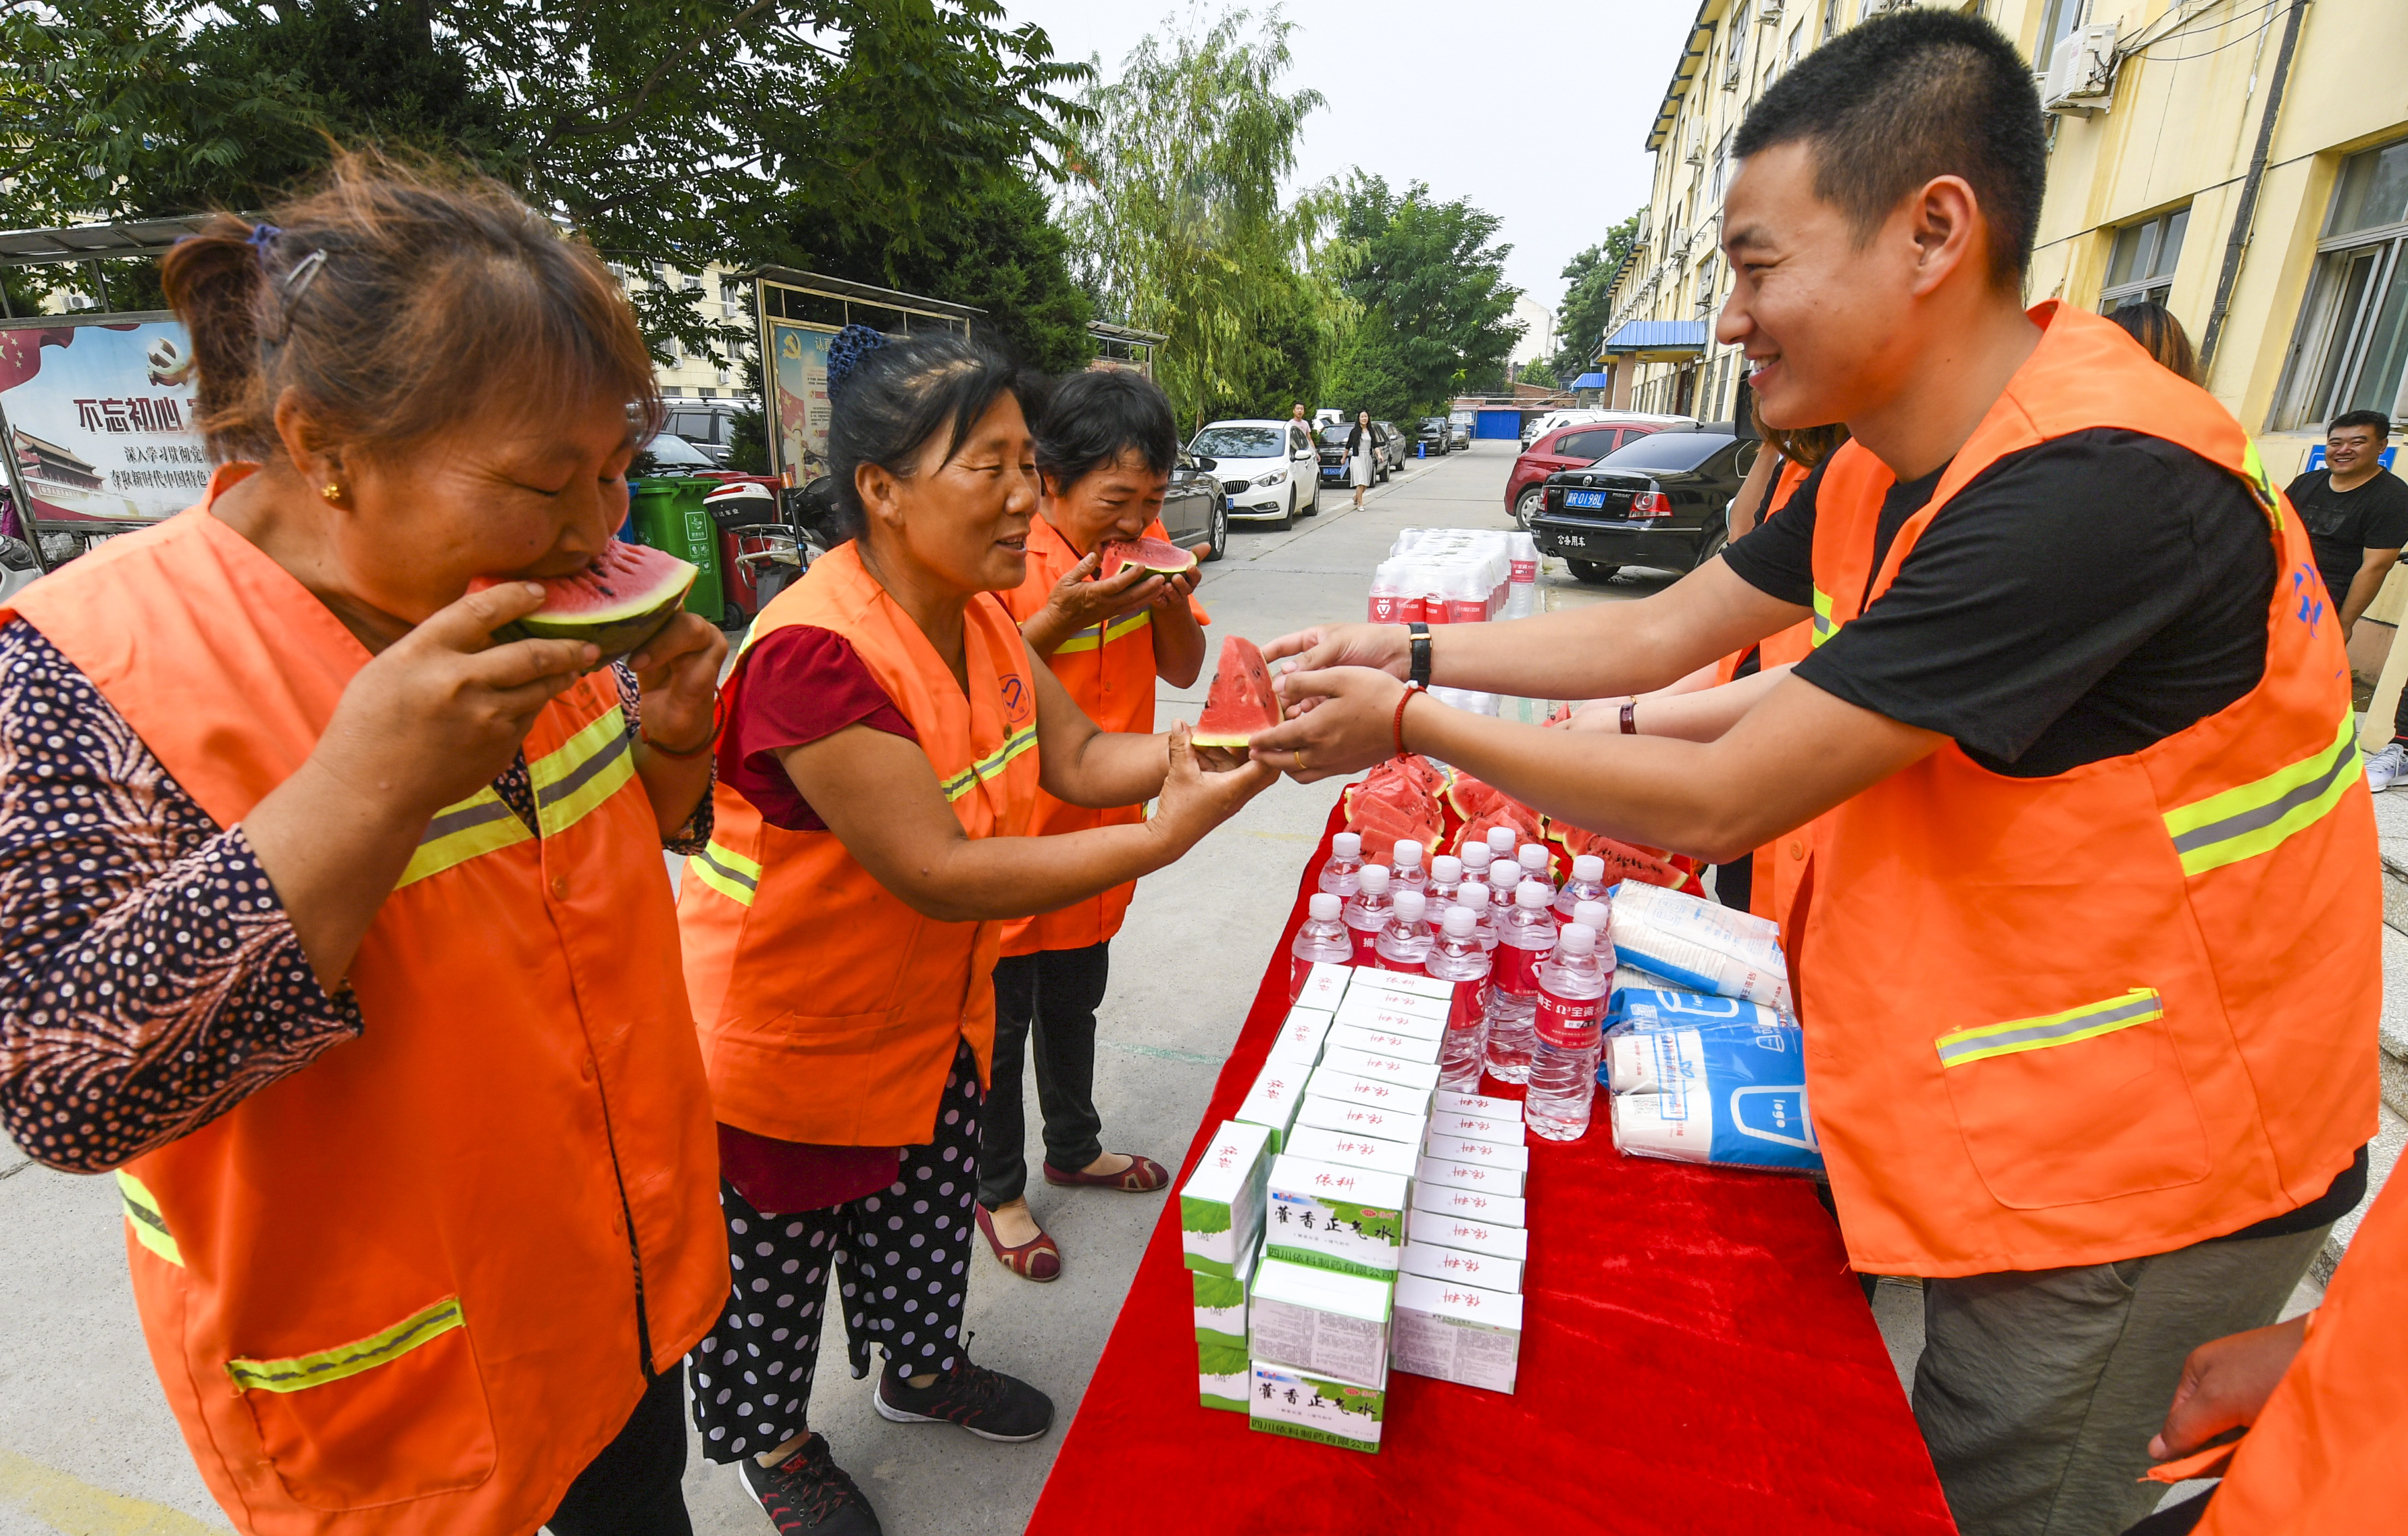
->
[0,623,363,1173]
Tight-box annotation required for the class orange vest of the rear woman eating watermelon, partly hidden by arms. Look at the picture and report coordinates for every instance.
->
[1002,517,1211,956]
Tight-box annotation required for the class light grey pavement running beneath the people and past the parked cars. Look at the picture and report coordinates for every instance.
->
[0,443,1669,1536]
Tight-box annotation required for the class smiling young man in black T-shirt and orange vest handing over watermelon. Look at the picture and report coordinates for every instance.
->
[1255,7,2382,1536]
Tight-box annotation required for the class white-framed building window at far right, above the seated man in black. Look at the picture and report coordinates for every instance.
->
[2276,140,2408,426]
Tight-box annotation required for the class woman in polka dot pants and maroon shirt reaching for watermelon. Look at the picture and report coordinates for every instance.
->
[679,328,1274,1531]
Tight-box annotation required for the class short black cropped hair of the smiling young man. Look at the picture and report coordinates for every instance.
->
[1732,9,2049,286]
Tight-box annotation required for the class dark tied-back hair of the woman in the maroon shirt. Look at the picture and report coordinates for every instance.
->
[828,325,1045,542]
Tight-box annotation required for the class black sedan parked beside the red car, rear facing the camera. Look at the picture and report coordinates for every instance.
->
[1529,431,1760,583]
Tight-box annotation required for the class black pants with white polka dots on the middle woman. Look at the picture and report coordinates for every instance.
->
[686,1045,982,1462]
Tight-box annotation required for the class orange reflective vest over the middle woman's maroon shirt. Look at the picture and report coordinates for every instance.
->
[676,544,1038,1146]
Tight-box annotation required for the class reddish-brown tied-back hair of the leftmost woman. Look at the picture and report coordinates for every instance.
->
[159,152,662,462]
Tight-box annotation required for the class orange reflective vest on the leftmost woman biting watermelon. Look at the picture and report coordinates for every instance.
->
[0,491,727,1536]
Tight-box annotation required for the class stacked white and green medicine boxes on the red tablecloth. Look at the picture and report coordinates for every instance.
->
[1180,965,1529,1452]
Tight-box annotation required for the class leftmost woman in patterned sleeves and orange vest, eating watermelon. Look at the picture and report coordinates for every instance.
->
[0,159,727,1536]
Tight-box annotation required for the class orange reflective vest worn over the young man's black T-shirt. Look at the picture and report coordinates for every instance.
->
[1792,303,2382,1276]
